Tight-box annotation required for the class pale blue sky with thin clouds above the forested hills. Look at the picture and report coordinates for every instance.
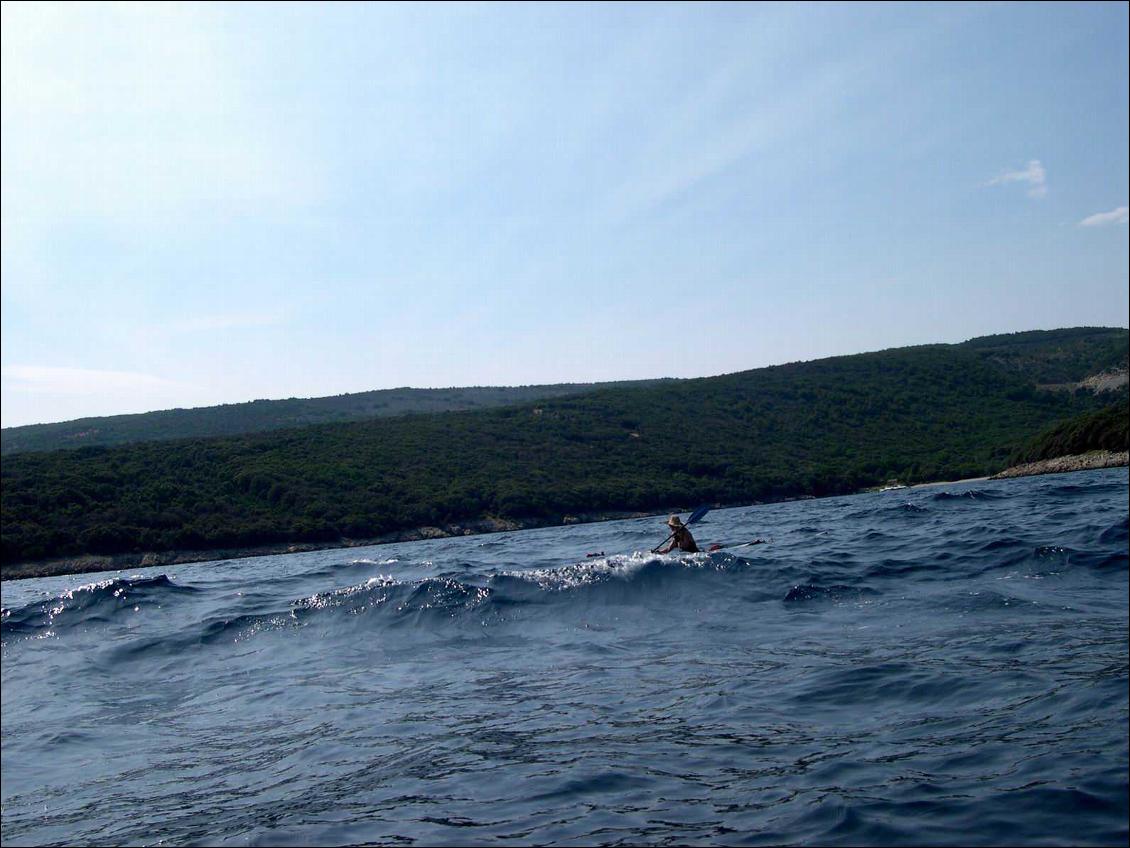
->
[0,2,1130,426]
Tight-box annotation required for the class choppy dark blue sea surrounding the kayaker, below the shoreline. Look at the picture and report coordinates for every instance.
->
[2,469,1128,845]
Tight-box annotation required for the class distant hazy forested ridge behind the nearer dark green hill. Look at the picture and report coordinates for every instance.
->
[0,380,660,456]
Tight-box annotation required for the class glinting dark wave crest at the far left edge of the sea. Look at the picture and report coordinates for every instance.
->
[0,574,198,637]
